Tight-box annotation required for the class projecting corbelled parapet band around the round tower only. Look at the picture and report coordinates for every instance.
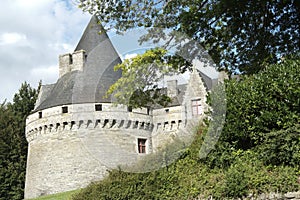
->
[26,103,153,142]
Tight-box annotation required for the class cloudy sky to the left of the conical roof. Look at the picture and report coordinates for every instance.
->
[0,0,90,103]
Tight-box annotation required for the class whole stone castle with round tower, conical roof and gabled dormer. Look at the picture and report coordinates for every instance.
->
[25,17,218,199]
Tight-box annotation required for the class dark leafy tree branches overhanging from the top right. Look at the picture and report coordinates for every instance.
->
[78,0,300,73]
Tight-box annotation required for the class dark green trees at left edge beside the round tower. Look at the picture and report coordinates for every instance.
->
[0,82,37,200]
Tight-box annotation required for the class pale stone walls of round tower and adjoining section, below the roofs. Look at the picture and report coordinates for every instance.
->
[25,103,183,198]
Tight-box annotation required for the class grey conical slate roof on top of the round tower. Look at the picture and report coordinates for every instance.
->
[35,16,121,111]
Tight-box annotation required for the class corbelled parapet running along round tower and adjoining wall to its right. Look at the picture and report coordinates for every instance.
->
[26,103,188,142]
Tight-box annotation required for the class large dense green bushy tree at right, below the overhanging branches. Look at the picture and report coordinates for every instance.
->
[208,58,300,167]
